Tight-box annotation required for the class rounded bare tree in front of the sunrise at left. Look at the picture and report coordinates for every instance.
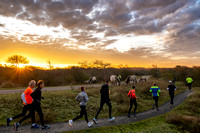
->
[6,55,29,68]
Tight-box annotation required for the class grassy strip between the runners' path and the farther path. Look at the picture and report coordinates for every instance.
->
[0,79,186,125]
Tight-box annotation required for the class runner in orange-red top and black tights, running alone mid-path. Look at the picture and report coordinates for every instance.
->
[127,86,137,117]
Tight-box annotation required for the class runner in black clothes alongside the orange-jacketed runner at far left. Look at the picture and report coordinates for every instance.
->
[31,80,50,130]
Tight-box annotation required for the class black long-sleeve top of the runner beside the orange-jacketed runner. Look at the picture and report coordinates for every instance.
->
[31,87,42,104]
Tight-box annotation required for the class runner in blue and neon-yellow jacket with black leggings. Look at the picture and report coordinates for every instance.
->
[150,83,160,111]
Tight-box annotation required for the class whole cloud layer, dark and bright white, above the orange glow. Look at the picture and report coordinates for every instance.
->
[0,0,200,66]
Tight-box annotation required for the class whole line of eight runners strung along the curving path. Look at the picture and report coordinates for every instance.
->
[7,76,193,131]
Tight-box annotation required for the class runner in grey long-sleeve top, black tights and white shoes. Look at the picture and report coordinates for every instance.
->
[69,87,93,127]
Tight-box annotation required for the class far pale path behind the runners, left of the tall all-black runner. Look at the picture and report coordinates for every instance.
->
[0,84,101,94]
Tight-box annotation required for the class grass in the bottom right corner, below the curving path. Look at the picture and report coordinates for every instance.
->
[67,88,200,133]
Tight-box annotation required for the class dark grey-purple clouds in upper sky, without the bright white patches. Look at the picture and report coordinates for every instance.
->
[0,0,200,64]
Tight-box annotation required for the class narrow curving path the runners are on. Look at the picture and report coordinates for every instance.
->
[0,90,190,133]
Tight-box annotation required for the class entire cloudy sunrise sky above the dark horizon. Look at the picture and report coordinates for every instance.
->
[0,0,200,67]
